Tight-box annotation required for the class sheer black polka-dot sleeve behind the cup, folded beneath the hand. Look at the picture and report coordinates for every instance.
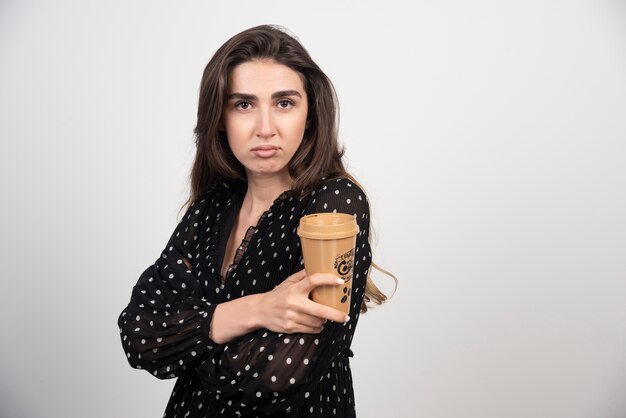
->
[198,179,371,415]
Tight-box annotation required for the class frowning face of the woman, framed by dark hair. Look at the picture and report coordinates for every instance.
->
[222,60,308,179]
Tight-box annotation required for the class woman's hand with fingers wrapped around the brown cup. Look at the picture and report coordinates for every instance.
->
[256,270,350,334]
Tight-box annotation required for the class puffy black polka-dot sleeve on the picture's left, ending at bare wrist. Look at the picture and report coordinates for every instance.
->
[118,200,215,379]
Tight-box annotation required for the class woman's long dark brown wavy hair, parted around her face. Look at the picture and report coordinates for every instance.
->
[187,25,387,312]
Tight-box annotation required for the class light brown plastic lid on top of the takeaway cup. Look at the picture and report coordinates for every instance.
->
[298,213,359,239]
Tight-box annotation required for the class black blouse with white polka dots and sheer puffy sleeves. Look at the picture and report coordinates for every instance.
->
[118,178,371,418]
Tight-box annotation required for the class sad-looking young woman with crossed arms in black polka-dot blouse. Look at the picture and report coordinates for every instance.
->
[118,26,386,418]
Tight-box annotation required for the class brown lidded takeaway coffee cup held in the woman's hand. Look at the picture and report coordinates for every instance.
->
[298,213,359,314]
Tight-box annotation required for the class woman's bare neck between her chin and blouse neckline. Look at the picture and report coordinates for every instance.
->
[241,173,292,215]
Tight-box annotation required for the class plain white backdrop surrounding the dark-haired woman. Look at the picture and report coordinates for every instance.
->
[0,0,626,418]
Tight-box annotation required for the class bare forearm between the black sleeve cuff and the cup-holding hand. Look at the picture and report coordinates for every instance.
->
[209,295,262,344]
